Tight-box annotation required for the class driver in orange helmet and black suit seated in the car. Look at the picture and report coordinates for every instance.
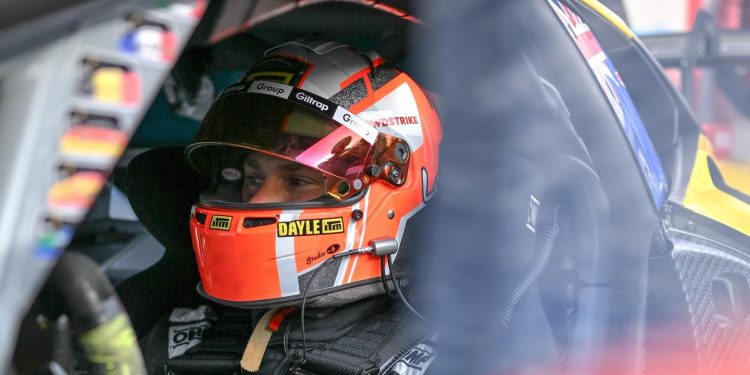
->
[166,41,442,374]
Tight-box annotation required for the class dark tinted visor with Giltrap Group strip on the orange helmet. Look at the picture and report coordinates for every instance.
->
[186,81,408,203]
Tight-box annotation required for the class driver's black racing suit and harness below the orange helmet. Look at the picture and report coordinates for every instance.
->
[142,296,435,375]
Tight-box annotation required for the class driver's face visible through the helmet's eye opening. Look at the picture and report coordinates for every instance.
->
[242,152,325,203]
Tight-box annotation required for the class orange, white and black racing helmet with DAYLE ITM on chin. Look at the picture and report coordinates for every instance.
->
[185,41,442,308]
